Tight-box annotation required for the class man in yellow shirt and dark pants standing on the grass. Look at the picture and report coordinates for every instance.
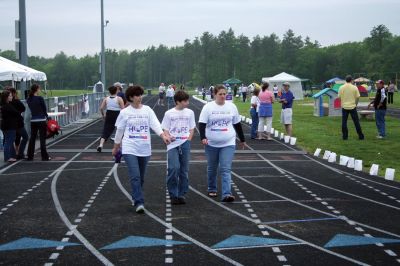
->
[339,75,364,140]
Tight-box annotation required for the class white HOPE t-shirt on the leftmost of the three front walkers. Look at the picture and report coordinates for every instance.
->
[115,105,163,157]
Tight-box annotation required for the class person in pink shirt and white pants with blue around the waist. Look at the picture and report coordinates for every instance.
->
[257,82,275,140]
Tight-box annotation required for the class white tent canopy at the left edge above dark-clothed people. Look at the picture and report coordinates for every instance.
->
[0,56,47,81]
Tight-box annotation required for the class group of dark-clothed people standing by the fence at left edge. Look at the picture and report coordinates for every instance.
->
[0,84,51,163]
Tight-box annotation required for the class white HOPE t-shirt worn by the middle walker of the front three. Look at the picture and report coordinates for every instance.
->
[161,108,196,151]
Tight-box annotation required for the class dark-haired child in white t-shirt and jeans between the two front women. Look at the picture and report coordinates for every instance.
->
[161,90,196,204]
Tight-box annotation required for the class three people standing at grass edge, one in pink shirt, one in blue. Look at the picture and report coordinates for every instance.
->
[250,82,294,140]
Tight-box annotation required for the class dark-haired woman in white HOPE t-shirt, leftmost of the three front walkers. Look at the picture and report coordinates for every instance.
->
[112,85,171,213]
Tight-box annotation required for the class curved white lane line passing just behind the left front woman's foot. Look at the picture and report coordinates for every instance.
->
[113,165,242,266]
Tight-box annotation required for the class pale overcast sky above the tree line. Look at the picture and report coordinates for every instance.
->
[0,0,400,57]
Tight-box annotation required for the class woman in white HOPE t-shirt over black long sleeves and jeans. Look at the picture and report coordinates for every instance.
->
[199,85,245,202]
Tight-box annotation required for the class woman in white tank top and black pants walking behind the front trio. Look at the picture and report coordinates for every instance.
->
[97,86,124,152]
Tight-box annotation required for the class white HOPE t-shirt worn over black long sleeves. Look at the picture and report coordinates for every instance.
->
[199,102,240,148]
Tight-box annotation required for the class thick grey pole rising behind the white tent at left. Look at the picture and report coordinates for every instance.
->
[19,0,28,99]
